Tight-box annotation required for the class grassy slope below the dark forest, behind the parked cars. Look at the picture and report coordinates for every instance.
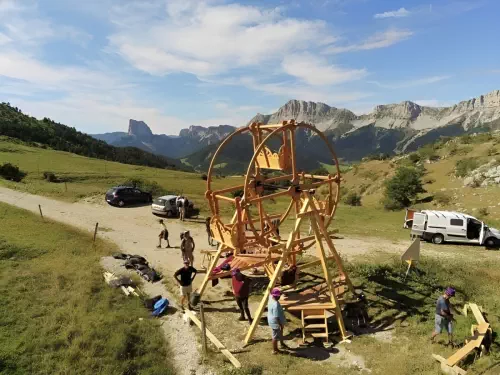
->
[0,138,231,214]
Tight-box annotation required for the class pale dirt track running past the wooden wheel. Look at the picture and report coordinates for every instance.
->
[0,188,497,375]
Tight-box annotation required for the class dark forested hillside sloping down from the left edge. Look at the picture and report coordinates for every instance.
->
[0,103,184,168]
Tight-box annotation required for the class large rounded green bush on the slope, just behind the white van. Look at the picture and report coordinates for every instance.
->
[382,166,425,210]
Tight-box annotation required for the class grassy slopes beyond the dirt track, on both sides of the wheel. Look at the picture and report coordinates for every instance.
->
[0,138,500,240]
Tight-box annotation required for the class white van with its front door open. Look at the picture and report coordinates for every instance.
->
[404,210,500,248]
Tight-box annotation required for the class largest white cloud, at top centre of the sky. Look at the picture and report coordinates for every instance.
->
[109,1,335,76]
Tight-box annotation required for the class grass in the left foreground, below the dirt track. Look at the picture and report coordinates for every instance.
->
[0,204,174,375]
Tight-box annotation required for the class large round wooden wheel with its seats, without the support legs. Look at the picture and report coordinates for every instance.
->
[206,121,340,252]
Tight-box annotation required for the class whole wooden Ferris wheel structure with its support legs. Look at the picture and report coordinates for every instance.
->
[199,120,354,343]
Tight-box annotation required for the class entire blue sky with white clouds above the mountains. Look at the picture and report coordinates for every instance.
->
[0,0,500,134]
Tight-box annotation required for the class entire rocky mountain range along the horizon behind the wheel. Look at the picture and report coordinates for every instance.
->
[94,90,500,172]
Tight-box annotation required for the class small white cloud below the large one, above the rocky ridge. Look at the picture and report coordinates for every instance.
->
[282,54,368,86]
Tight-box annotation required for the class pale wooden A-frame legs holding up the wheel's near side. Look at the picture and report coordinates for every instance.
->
[245,192,354,344]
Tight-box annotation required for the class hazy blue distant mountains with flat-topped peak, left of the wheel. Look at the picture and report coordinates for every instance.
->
[92,119,236,159]
